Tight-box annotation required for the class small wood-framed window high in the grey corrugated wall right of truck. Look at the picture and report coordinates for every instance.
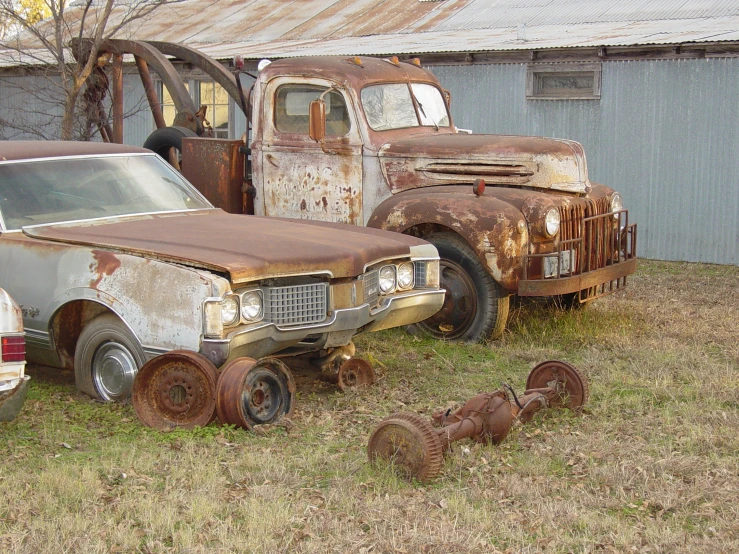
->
[526,64,600,100]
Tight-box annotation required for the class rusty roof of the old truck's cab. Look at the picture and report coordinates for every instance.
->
[260,56,438,85]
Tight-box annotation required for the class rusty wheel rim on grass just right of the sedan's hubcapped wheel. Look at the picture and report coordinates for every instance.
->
[131,350,217,431]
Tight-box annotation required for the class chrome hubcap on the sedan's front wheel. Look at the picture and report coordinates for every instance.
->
[92,341,138,402]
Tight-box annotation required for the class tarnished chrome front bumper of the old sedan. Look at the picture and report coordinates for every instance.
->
[200,290,445,366]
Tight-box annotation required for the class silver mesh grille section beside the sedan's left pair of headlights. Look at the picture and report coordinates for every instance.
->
[264,283,328,325]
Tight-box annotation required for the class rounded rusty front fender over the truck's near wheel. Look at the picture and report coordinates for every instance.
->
[367,187,528,291]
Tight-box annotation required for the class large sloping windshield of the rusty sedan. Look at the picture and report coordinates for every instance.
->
[0,155,212,230]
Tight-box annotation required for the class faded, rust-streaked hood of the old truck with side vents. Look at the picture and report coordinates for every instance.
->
[379,133,590,193]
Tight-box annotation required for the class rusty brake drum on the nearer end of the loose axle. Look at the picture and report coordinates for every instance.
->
[367,413,444,481]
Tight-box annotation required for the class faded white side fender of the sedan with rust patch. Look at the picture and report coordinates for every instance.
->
[0,233,221,354]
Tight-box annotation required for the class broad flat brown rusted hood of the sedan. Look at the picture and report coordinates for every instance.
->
[23,209,436,283]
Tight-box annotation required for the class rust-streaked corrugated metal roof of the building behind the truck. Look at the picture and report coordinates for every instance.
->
[0,0,739,66]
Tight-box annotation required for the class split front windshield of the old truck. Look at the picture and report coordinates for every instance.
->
[362,83,449,131]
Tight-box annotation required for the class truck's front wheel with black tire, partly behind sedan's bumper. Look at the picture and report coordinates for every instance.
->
[418,233,509,342]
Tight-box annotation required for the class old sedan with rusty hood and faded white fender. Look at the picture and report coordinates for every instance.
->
[0,142,444,401]
